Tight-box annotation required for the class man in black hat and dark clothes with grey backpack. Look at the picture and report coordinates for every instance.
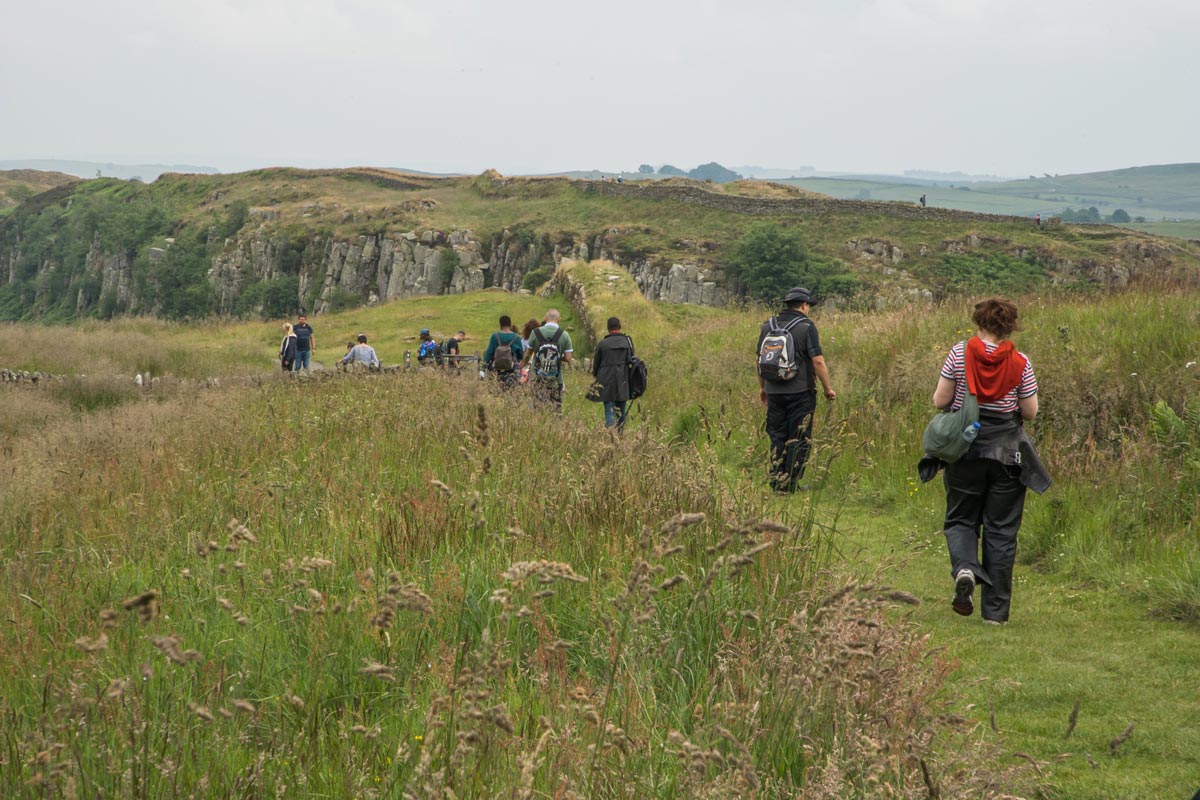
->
[758,287,838,492]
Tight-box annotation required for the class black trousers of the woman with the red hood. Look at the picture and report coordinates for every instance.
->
[944,458,1025,622]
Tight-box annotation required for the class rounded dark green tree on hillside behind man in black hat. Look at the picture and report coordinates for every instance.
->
[731,222,859,302]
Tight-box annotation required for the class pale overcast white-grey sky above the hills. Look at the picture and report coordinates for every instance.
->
[0,0,1200,176]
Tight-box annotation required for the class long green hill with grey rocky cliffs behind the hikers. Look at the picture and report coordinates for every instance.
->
[0,168,1200,319]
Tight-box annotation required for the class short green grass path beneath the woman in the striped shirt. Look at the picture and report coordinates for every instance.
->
[838,506,1200,800]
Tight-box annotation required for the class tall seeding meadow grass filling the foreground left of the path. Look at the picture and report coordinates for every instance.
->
[0,362,1030,798]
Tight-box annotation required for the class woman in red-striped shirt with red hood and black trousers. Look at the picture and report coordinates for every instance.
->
[934,297,1050,625]
